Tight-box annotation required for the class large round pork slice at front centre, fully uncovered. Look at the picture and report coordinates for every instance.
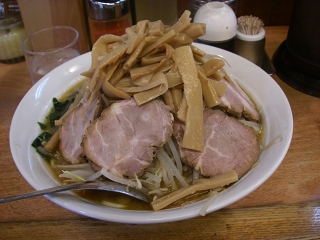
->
[82,98,173,178]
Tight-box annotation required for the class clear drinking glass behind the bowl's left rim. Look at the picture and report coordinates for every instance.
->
[22,26,80,84]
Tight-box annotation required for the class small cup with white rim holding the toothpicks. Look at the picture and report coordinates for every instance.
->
[234,28,266,67]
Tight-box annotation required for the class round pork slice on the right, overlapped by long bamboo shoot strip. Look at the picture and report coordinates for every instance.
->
[173,109,260,178]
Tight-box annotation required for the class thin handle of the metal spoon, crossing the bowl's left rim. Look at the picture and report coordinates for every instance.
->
[0,182,94,204]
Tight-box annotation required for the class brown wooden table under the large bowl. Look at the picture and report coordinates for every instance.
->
[0,26,320,240]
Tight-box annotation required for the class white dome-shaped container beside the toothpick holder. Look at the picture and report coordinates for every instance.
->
[193,2,237,42]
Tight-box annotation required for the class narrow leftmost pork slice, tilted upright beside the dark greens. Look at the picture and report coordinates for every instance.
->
[59,96,101,164]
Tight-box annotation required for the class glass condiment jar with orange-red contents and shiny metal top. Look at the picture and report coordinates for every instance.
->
[86,0,132,44]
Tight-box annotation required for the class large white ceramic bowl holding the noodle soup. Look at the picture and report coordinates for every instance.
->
[10,44,293,224]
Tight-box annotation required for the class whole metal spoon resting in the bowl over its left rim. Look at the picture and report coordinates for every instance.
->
[0,180,150,204]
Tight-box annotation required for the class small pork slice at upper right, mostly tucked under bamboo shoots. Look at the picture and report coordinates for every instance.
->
[219,79,261,123]
